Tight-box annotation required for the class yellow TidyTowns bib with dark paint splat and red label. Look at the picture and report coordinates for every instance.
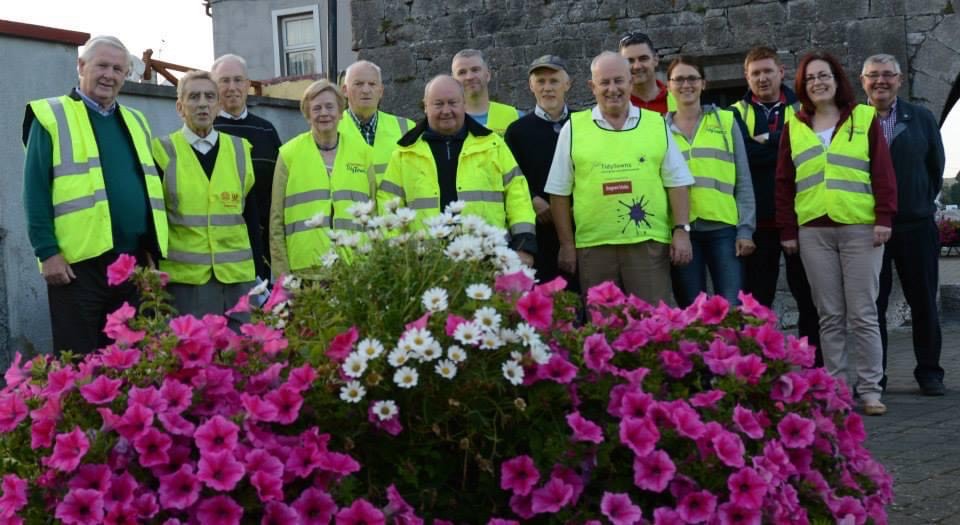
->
[570,109,671,248]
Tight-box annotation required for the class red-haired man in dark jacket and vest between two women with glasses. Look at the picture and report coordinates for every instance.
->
[730,46,823,365]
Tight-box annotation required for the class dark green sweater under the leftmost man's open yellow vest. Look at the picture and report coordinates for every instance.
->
[23,103,152,261]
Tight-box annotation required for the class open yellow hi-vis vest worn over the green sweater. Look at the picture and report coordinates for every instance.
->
[29,96,167,263]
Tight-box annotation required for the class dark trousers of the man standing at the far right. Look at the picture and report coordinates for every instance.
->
[877,218,943,383]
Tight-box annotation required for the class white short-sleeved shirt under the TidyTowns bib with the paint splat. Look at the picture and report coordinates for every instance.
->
[543,104,693,195]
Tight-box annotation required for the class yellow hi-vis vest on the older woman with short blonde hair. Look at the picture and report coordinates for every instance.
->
[280,131,374,271]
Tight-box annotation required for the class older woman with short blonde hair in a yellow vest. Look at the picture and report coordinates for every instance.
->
[270,79,375,279]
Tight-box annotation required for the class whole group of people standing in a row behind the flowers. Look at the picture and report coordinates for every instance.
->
[24,32,944,415]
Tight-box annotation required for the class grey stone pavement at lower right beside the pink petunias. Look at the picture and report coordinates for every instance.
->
[864,320,960,525]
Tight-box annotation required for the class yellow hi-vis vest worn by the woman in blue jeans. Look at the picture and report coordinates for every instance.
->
[673,108,739,226]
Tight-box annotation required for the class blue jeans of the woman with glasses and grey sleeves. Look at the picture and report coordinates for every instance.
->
[673,226,743,308]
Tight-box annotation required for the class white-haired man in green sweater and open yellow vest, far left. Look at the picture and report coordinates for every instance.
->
[23,36,167,353]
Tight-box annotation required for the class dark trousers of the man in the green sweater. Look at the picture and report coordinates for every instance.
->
[47,252,139,355]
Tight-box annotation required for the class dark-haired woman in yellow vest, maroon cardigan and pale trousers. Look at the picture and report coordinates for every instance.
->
[776,52,897,415]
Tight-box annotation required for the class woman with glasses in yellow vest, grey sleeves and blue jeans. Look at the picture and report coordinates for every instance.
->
[664,56,756,307]
